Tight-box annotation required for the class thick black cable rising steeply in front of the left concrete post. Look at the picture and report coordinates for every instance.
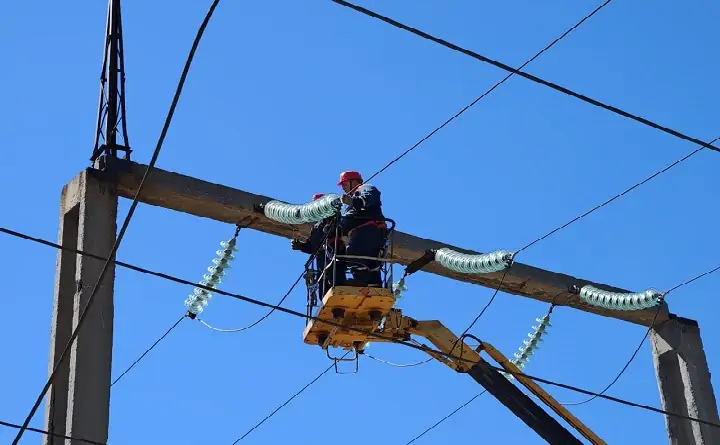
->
[12,0,220,445]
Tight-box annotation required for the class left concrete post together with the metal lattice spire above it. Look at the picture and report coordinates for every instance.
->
[43,0,124,445]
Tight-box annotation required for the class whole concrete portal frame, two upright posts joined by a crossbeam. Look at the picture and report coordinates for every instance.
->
[46,161,720,445]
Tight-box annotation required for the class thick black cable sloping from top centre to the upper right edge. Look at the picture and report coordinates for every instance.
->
[330,0,720,151]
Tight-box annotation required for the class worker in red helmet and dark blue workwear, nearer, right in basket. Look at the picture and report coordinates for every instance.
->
[338,171,387,286]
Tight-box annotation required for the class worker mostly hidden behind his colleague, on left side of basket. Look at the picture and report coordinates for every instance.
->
[291,193,346,294]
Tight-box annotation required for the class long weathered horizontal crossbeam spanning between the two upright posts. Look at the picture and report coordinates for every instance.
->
[101,162,669,326]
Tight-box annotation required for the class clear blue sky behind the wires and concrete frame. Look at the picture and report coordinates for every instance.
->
[0,0,720,445]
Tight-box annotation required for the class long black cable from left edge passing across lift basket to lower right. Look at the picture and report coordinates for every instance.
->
[0,228,720,428]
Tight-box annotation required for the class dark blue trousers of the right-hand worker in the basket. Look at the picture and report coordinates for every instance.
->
[346,225,386,286]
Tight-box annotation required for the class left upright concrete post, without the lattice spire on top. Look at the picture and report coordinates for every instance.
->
[43,171,118,445]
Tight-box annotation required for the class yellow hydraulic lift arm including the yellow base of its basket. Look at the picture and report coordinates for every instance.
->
[304,286,605,445]
